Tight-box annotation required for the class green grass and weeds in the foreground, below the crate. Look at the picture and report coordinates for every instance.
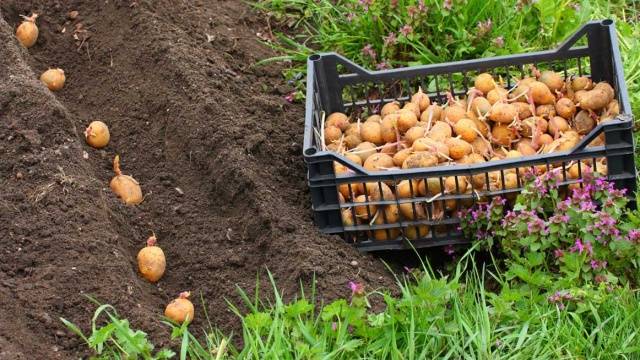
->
[63,252,640,360]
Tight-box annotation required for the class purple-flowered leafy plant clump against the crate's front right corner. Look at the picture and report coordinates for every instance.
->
[461,167,640,300]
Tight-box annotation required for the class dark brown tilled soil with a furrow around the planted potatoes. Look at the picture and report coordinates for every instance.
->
[0,0,393,359]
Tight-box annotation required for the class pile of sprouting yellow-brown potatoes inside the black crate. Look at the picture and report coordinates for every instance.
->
[321,68,620,240]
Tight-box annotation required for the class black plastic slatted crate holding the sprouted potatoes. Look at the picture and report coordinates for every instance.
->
[303,20,636,251]
